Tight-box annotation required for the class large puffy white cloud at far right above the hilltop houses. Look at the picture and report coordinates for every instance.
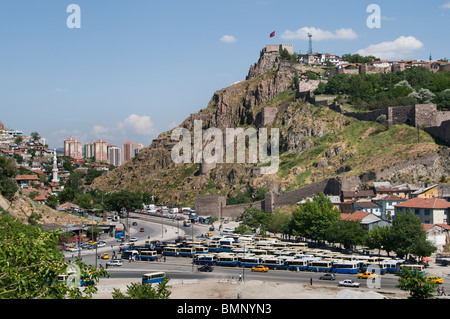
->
[357,36,423,59]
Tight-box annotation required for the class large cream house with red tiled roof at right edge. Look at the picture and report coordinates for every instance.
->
[395,197,450,225]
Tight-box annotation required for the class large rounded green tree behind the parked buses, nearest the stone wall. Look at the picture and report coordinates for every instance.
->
[291,193,340,244]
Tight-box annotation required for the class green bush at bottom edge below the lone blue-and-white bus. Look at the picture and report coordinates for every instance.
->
[112,277,171,299]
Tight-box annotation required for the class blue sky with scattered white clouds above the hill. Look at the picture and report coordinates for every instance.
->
[0,0,450,148]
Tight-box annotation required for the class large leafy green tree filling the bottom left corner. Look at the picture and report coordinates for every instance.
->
[0,215,107,299]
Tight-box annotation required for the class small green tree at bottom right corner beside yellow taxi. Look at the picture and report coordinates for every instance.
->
[397,268,438,299]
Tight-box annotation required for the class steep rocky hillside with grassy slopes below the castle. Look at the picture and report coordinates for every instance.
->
[92,49,448,205]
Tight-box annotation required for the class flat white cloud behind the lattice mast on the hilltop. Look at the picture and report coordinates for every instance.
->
[281,27,358,41]
